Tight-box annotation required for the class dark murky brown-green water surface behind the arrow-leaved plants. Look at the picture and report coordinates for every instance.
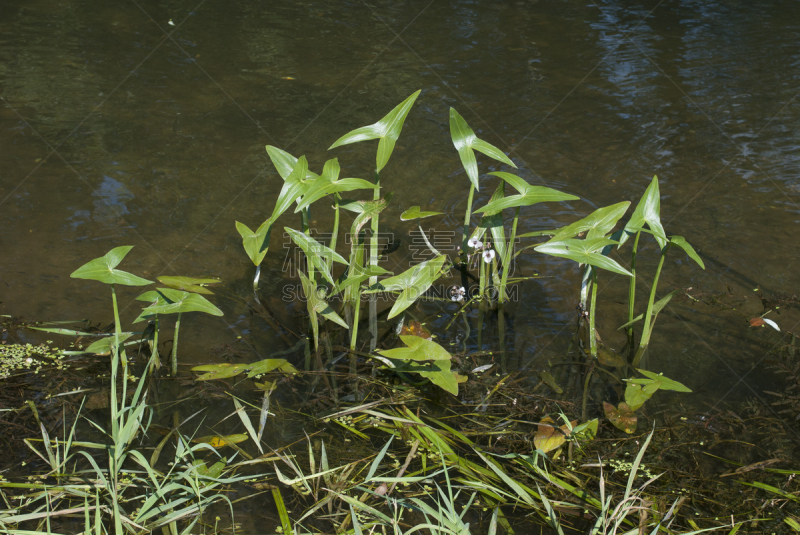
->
[0,0,800,478]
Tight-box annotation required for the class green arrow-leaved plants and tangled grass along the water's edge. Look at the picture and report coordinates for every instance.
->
[0,91,772,535]
